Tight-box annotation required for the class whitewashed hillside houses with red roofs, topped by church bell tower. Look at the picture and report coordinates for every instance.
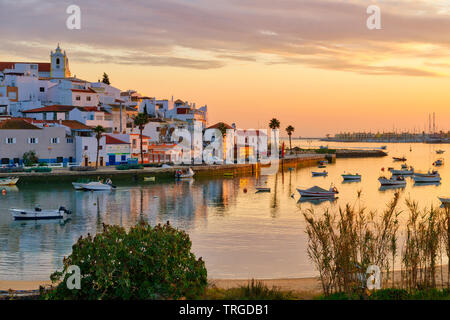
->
[0,45,214,166]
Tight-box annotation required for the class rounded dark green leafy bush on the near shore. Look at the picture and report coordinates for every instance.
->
[44,222,207,300]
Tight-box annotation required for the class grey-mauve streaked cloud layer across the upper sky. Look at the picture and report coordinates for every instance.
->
[0,0,450,77]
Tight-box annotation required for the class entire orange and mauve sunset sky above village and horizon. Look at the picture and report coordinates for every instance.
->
[0,0,450,137]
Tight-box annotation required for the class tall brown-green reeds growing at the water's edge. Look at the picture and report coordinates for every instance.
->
[303,191,450,297]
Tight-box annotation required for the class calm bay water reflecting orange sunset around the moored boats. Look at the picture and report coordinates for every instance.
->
[0,141,450,280]
